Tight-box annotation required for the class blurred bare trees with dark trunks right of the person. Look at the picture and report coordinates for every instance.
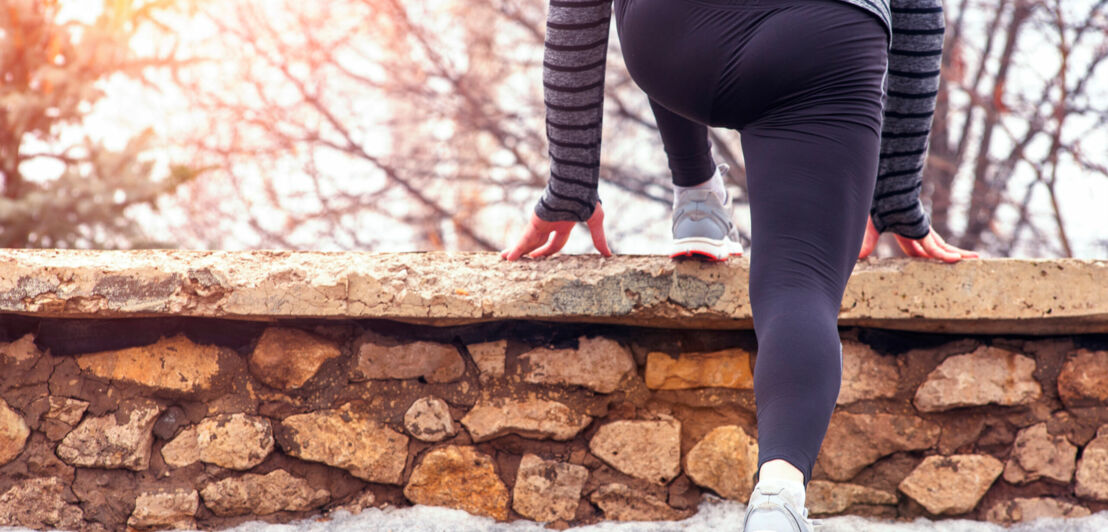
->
[924,0,1108,257]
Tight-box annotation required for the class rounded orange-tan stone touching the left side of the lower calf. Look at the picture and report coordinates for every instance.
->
[685,424,758,503]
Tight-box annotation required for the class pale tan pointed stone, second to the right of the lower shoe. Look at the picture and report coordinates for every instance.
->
[900,454,1004,515]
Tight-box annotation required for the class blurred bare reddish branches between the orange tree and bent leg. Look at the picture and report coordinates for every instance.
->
[167,0,670,249]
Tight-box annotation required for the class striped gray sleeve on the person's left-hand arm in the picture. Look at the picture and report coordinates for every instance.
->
[535,0,612,222]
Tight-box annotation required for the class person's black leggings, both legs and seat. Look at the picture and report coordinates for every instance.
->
[615,0,888,481]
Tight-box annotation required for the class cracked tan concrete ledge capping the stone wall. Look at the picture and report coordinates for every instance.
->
[0,249,1108,335]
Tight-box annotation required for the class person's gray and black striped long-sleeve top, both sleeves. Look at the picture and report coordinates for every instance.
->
[535,0,944,238]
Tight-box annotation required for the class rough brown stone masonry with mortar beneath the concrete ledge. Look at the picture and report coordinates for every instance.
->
[0,254,1108,531]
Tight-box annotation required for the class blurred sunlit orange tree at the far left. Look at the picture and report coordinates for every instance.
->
[0,0,194,247]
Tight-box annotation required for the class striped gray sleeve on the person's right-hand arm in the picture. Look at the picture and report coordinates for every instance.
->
[870,0,945,238]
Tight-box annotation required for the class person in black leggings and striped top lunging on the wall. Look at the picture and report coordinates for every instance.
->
[502,0,977,531]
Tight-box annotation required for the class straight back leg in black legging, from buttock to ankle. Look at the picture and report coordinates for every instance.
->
[735,1,886,479]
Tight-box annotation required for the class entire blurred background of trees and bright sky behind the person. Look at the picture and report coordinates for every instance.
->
[0,0,1108,258]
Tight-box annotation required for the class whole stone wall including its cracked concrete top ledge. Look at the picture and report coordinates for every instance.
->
[0,252,1108,531]
